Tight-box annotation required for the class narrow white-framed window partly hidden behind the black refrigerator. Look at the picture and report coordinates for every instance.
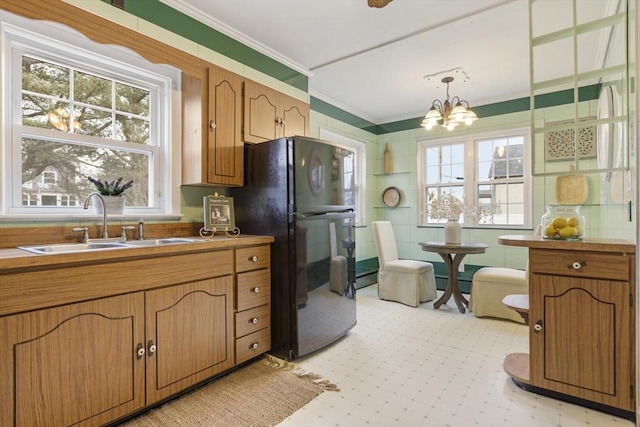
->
[320,128,367,226]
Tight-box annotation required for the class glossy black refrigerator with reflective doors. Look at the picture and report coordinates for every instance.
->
[230,136,356,360]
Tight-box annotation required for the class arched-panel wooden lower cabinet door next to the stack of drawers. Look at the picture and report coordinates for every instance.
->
[145,276,234,403]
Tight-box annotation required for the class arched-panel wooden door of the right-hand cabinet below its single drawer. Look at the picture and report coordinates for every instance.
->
[530,274,632,410]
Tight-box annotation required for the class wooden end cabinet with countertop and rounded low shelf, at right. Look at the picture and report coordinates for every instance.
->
[498,236,636,419]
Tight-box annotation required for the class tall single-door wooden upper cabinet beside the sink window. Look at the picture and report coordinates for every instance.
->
[182,63,244,186]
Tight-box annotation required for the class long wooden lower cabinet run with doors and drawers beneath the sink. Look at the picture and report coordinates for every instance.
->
[0,241,271,427]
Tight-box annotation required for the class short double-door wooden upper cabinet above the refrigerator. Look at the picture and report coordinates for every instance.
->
[244,81,309,143]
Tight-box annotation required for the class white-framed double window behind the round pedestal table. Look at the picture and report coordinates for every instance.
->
[418,128,532,228]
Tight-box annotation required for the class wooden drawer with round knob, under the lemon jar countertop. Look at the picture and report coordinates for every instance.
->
[530,250,629,281]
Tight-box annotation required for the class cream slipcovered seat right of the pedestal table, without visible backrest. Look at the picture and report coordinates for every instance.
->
[470,267,529,323]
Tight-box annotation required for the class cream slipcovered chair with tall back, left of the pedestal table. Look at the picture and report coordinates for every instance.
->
[372,221,436,307]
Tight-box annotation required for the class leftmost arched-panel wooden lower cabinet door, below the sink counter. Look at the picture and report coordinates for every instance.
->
[0,293,145,426]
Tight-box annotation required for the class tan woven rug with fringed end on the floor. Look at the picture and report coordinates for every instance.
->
[120,355,338,427]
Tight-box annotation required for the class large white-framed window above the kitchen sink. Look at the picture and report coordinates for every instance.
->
[0,12,181,219]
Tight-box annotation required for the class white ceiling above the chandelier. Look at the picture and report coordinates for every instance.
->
[162,0,617,124]
